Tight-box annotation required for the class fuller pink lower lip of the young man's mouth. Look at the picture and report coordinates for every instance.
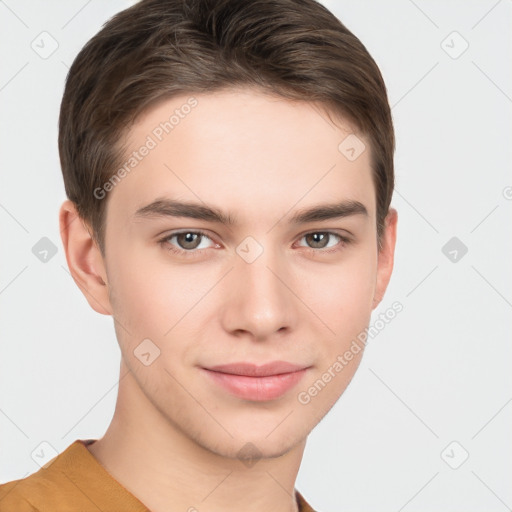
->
[203,368,307,402]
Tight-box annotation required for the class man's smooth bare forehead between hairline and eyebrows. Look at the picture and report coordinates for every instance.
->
[105,89,375,229]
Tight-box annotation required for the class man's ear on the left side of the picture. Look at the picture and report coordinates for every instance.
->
[59,200,112,315]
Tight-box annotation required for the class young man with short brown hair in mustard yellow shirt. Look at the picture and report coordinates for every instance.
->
[0,0,397,512]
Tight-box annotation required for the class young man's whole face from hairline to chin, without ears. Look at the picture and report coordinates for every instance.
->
[75,89,394,458]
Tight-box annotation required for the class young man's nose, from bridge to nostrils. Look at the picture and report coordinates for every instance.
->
[221,242,303,341]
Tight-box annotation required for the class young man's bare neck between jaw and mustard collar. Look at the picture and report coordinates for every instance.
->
[88,362,306,512]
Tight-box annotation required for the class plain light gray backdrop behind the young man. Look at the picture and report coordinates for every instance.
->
[0,0,512,512]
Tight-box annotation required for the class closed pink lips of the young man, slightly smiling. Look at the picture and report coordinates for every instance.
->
[201,361,310,402]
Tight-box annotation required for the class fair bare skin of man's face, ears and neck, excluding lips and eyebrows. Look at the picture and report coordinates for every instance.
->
[59,89,397,512]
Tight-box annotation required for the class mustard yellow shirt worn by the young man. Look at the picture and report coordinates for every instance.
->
[0,439,315,512]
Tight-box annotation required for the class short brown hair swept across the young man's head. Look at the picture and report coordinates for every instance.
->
[59,0,395,255]
